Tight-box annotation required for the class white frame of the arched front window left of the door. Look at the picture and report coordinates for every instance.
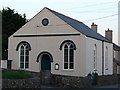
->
[19,44,30,70]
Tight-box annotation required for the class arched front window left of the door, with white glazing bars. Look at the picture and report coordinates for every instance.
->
[19,43,29,69]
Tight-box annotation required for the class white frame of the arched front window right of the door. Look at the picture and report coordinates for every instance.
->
[63,42,75,70]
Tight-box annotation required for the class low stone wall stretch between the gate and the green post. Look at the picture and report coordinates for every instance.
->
[51,74,92,88]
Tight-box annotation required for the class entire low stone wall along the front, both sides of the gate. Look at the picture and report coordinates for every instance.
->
[2,69,120,89]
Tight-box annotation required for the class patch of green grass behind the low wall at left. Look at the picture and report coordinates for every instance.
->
[2,70,33,79]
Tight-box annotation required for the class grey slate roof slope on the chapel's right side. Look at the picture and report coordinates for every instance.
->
[47,8,112,43]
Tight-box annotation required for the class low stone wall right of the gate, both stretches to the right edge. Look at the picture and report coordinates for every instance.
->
[51,74,120,88]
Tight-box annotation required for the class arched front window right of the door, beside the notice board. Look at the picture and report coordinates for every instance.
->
[63,42,74,70]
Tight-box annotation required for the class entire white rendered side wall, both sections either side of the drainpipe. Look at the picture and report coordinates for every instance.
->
[86,37,113,75]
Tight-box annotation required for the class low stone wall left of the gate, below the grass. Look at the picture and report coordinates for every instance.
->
[2,78,40,88]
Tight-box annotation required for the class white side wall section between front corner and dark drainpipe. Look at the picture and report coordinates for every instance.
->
[86,37,102,75]
